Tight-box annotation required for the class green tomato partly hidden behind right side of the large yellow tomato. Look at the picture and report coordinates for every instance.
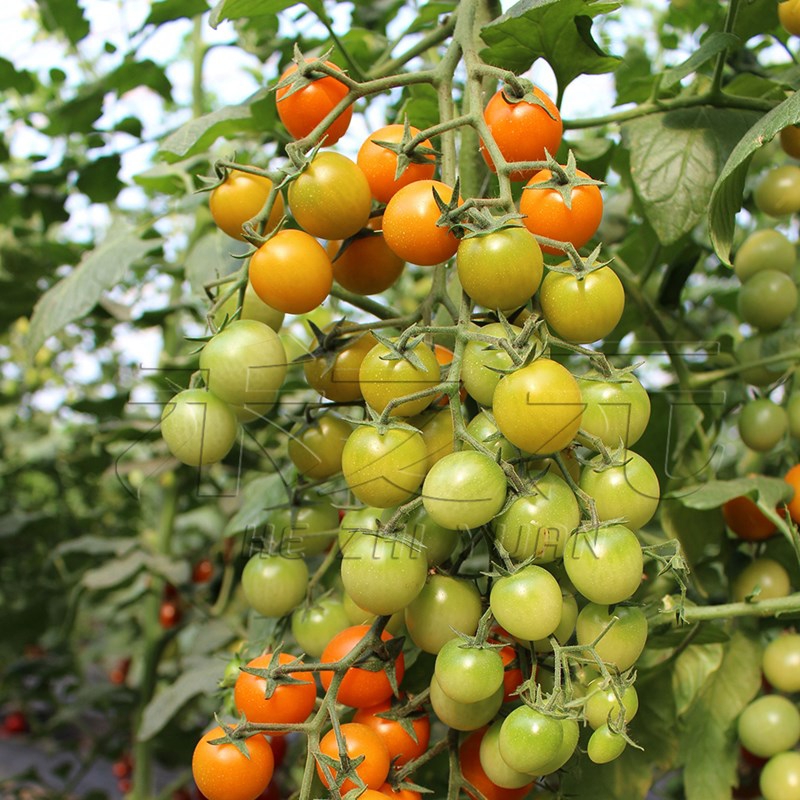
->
[578,373,650,447]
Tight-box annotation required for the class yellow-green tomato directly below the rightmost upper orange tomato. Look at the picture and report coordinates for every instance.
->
[539,267,625,344]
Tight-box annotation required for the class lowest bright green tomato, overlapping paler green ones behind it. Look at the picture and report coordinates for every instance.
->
[498,706,564,774]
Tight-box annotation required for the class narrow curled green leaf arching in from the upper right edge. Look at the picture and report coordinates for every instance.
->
[708,92,800,265]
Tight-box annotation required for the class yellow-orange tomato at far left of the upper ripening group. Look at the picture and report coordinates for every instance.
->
[208,169,283,241]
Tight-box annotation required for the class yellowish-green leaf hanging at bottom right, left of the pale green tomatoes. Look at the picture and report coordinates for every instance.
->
[681,632,761,800]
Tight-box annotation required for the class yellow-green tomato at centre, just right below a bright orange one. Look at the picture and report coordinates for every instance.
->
[456,225,544,311]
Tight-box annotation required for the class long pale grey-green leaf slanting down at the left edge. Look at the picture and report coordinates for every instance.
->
[27,226,161,357]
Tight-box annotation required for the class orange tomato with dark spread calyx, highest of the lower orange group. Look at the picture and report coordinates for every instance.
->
[320,625,405,708]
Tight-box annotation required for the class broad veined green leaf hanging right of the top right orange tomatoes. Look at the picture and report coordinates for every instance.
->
[623,106,757,244]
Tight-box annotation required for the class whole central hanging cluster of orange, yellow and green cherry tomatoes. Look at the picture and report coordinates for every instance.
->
[166,54,660,800]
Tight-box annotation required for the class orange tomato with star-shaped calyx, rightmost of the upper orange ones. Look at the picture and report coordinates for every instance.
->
[519,169,603,255]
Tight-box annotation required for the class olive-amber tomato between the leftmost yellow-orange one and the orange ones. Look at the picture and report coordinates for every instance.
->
[289,152,372,239]
